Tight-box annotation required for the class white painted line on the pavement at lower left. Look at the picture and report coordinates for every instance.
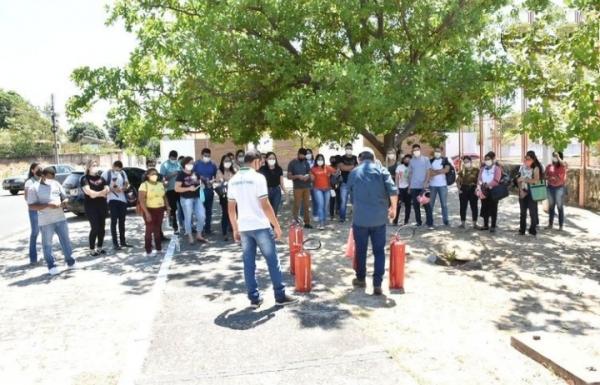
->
[119,236,179,385]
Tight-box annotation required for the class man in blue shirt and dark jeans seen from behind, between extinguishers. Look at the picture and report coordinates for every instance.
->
[348,150,398,295]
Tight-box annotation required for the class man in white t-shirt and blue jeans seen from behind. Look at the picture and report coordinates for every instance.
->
[227,151,298,308]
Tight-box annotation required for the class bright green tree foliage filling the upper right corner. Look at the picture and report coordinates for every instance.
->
[502,0,600,150]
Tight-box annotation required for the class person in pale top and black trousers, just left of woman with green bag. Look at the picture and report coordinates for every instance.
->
[475,151,502,233]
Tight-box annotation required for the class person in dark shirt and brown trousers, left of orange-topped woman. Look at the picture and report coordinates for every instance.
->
[287,148,312,229]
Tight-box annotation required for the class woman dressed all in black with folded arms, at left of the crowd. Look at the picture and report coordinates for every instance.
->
[81,160,110,257]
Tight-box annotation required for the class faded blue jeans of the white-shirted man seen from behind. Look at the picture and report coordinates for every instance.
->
[240,228,285,301]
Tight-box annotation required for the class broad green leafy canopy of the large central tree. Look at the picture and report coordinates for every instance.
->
[68,0,512,152]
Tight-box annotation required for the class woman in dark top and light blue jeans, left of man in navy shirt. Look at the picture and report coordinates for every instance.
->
[175,156,206,244]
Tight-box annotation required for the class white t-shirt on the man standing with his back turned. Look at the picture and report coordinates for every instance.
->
[227,167,271,232]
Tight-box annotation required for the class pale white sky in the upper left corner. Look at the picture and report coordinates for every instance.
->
[0,0,135,129]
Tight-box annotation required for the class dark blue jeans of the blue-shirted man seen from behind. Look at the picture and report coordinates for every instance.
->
[352,225,386,287]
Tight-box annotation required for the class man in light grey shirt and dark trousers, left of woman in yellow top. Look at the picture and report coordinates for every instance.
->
[102,160,131,250]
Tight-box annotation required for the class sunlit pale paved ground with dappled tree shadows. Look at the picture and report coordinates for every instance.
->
[0,188,600,385]
